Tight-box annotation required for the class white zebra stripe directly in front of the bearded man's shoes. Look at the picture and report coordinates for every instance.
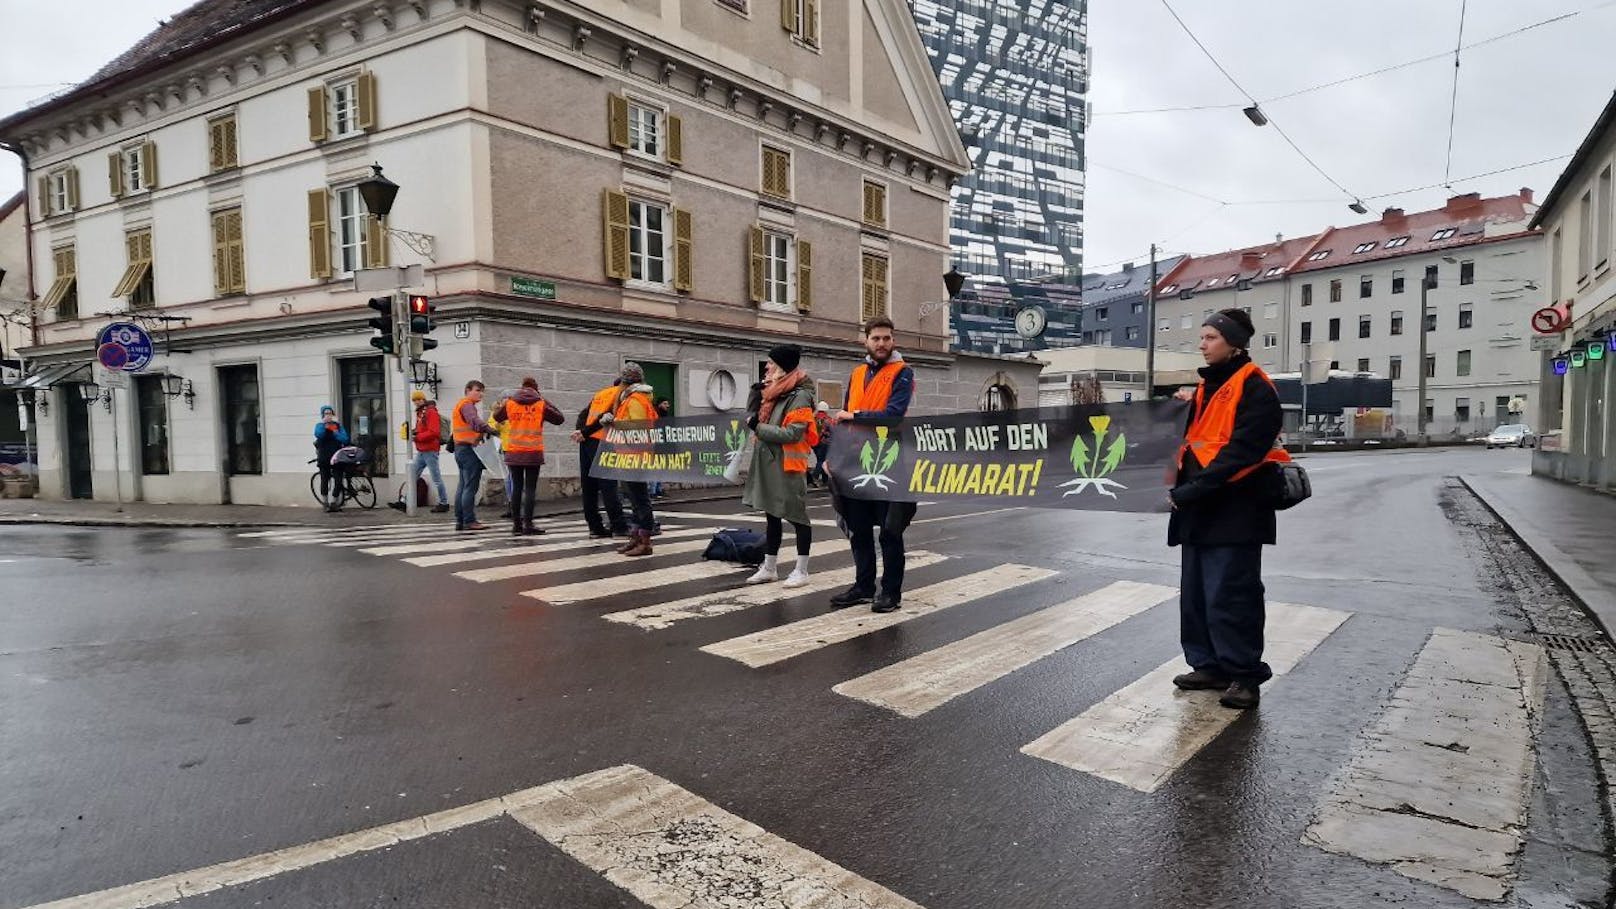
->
[701,564,1057,668]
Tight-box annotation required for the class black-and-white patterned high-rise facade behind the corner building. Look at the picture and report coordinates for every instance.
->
[910,0,1089,283]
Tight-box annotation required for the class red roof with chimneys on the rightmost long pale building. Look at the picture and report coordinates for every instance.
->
[1294,189,1535,272]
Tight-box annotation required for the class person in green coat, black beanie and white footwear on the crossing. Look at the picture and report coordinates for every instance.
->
[740,345,819,587]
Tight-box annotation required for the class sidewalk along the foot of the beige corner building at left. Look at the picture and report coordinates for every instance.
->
[0,487,740,527]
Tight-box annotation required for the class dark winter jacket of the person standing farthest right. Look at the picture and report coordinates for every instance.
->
[1167,356,1285,547]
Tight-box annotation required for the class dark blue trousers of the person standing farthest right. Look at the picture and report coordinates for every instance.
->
[1178,543,1273,684]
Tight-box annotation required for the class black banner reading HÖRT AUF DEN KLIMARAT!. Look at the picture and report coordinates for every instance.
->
[827,401,1189,511]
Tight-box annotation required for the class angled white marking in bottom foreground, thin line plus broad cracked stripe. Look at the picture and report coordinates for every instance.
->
[29,763,921,909]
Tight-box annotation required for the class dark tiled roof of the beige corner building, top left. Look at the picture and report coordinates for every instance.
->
[0,0,323,129]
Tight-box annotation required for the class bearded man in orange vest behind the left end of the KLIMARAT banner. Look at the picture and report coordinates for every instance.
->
[831,317,915,613]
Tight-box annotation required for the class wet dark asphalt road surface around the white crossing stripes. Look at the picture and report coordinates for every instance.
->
[0,450,1611,909]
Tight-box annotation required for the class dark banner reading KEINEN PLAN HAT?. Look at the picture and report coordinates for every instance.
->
[590,414,751,485]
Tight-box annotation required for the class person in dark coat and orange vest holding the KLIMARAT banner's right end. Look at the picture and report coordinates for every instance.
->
[1167,309,1285,710]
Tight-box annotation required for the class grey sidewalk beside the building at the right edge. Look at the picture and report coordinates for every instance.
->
[1459,474,1616,641]
